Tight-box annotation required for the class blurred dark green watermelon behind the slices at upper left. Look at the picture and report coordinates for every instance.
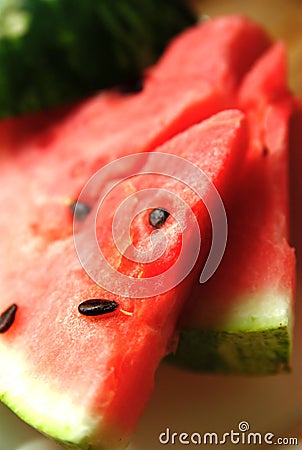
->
[0,0,197,117]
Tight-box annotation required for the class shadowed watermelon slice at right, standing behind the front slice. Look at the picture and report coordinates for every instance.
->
[172,44,297,374]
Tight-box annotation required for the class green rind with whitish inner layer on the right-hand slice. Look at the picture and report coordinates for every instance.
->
[167,293,293,375]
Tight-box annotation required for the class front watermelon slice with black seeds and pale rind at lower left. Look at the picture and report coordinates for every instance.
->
[0,111,246,449]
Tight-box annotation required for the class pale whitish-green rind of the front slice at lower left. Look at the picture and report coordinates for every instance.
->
[0,343,97,450]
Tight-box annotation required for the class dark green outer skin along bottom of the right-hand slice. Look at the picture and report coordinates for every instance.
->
[167,326,291,375]
